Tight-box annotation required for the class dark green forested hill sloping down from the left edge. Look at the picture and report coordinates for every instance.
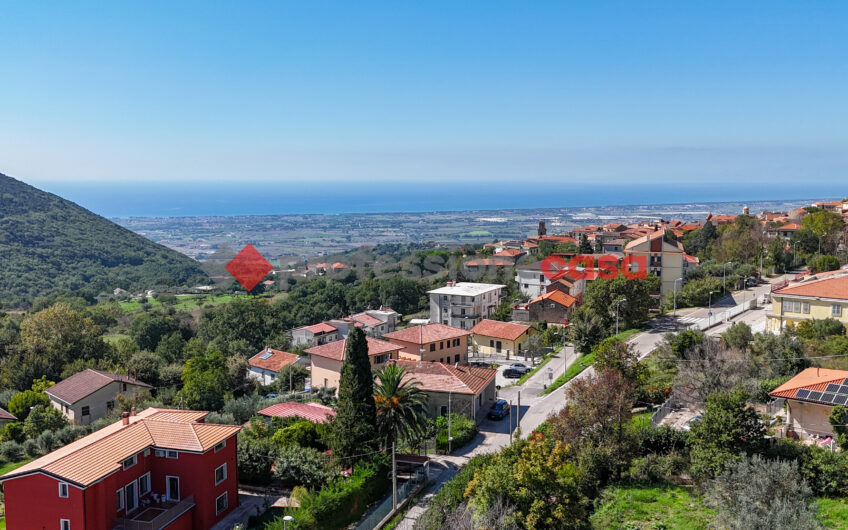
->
[0,173,207,308]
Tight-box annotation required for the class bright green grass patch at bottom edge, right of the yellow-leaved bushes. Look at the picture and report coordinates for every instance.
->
[589,483,715,530]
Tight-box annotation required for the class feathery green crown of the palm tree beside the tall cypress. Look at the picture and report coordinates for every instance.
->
[374,364,428,447]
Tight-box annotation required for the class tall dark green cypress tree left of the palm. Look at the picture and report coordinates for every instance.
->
[331,328,377,458]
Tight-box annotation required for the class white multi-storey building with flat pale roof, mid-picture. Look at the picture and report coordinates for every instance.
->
[427,282,506,329]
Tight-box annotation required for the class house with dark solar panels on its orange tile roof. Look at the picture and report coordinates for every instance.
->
[769,368,848,440]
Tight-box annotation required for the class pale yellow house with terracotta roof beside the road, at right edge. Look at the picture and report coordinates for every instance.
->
[766,270,848,332]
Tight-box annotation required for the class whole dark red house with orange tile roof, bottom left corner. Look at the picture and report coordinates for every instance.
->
[0,408,240,530]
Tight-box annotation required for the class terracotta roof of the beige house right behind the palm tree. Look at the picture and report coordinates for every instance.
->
[392,361,498,395]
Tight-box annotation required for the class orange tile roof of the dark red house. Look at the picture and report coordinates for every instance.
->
[0,409,241,487]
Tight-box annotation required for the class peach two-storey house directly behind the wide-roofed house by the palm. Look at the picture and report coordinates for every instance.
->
[383,324,471,363]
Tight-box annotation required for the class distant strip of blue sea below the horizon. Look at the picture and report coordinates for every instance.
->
[35,179,842,218]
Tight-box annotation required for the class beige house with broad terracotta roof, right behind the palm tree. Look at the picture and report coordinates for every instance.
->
[394,360,497,423]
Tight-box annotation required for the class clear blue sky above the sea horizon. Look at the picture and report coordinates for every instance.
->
[0,1,848,191]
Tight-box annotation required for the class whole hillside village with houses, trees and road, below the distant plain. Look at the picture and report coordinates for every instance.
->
[0,196,848,530]
